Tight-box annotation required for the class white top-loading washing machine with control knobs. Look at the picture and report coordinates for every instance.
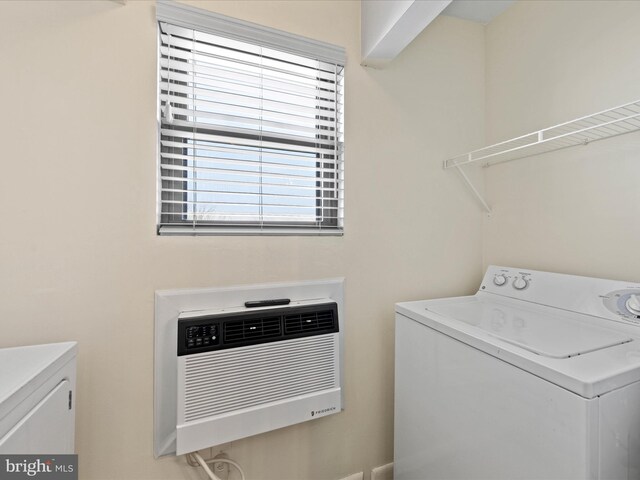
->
[394,266,640,480]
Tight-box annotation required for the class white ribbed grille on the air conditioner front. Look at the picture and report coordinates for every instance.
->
[179,334,339,422]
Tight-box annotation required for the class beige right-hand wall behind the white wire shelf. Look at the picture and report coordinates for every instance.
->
[483,1,640,281]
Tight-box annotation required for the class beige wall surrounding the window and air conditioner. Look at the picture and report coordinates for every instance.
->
[0,0,484,480]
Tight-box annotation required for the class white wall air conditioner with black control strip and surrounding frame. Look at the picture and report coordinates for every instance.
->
[154,279,343,457]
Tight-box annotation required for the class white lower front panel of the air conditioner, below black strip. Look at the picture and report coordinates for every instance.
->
[177,333,341,454]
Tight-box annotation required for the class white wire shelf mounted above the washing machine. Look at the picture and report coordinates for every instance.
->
[444,100,640,168]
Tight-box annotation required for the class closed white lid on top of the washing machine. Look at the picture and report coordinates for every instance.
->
[428,297,633,358]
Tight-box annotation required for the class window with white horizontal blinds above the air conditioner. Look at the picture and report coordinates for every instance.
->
[157,2,344,235]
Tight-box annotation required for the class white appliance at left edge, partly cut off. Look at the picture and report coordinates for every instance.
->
[0,342,76,454]
